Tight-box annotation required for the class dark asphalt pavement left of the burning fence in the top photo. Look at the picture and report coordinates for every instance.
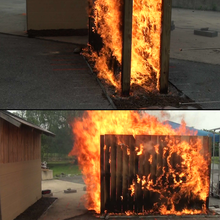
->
[0,34,112,109]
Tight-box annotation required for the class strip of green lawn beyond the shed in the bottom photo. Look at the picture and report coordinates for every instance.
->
[47,161,81,176]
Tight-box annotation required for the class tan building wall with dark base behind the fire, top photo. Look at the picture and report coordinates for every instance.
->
[26,0,88,36]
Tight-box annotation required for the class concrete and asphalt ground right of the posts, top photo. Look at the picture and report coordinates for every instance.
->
[169,8,220,109]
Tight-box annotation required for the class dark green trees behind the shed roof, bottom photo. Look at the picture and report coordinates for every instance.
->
[14,110,84,158]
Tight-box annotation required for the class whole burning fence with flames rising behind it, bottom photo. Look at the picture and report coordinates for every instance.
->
[70,111,210,215]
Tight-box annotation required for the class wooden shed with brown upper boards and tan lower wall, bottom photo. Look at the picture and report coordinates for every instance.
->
[0,111,55,220]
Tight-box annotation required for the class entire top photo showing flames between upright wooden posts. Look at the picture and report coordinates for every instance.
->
[0,0,220,110]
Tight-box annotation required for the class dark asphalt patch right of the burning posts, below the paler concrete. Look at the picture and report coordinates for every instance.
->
[169,59,220,109]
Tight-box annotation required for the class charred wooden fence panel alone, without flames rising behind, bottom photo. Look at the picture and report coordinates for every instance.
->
[100,135,210,215]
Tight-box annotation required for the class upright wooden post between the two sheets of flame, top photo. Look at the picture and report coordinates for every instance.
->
[121,0,133,96]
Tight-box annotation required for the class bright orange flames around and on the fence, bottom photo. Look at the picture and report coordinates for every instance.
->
[69,111,209,215]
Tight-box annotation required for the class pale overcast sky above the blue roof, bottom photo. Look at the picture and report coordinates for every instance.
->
[146,110,220,129]
